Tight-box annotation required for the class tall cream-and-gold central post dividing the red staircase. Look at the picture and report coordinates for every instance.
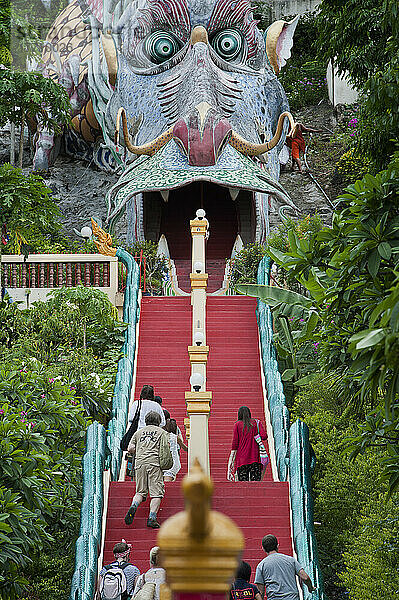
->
[185,210,212,475]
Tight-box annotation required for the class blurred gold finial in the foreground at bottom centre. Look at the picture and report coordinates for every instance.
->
[158,460,244,594]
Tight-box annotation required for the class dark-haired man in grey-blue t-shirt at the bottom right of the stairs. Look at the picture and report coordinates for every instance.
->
[255,534,316,600]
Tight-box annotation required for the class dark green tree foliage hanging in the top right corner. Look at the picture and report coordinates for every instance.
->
[318,0,399,170]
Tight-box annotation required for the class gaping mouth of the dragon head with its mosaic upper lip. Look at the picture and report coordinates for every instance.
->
[108,140,296,253]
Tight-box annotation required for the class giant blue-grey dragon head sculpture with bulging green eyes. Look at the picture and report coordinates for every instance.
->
[38,0,296,253]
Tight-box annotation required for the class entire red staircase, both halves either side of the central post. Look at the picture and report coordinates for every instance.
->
[104,296,292,575]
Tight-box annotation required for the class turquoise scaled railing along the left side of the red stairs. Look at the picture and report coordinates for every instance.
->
[70,248,140,600]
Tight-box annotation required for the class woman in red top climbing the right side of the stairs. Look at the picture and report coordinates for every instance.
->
[227,406,267,481]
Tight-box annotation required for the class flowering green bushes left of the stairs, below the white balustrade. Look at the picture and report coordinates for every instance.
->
[0,288,125,600]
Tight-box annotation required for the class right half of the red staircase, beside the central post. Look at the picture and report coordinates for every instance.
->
[206,296,292,576]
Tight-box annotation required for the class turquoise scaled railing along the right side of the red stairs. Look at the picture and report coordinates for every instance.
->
[257,257,325,600]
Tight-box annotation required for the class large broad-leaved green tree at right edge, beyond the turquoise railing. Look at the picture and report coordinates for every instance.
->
[250,157,399,493]
